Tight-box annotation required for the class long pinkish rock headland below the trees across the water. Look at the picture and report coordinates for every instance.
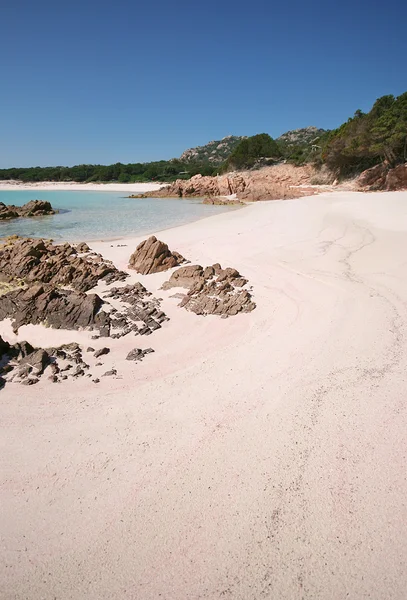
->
[135,164,316,202]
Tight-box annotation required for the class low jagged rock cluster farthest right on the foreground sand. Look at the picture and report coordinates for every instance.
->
[162,263,256,317]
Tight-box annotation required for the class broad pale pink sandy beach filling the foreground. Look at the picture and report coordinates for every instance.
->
[0,192,407,600]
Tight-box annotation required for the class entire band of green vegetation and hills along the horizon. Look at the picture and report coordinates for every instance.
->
[0,92,407,183]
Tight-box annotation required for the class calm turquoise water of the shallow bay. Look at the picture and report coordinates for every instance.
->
[0,190,236,242]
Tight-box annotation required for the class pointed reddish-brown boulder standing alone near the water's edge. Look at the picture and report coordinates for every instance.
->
[129,235,185,275]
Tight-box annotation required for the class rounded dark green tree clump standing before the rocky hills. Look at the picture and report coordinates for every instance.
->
[222,133,281,172]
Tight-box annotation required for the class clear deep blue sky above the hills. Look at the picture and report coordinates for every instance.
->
[0,0,407,167]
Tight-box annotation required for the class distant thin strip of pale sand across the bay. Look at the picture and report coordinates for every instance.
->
[0,180,163,193]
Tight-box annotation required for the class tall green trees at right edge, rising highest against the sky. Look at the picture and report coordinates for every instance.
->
[319,92,407,178]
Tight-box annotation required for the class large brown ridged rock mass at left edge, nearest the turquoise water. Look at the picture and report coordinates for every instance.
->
[0,237,128,292]
